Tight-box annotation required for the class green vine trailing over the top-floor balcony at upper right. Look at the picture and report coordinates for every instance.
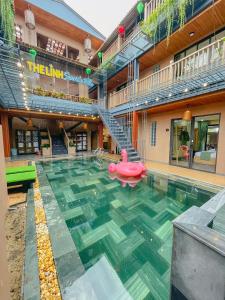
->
[141,0,194,43]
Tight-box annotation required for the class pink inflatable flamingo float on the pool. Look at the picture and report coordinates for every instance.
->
[108,149,147,187]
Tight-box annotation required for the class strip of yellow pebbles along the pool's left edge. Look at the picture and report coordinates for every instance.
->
[34,180,62,300]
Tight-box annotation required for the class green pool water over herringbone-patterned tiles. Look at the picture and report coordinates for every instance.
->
[42,159,213,299]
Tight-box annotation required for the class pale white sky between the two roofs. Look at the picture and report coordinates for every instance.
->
[65,0,137,37]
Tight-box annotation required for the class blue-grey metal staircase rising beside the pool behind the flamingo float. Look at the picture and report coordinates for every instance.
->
[97,106,140,161]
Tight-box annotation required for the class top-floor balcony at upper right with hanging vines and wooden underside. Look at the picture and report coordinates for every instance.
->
[92,0,224,82]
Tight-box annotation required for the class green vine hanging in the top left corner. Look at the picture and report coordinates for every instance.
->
[0,0,15,42]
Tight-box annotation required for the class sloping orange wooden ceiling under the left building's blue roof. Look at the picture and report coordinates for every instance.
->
[15,0,103,49]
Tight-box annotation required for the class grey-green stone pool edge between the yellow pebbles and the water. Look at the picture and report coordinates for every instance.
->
[36,164,85,300]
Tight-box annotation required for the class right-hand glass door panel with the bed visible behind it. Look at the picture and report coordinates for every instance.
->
[191,115,220,172]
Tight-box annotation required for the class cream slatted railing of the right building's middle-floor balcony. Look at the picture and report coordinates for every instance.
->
[109,38,225,108]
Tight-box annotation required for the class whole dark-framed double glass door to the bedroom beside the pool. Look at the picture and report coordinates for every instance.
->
[170,114,220,172]
